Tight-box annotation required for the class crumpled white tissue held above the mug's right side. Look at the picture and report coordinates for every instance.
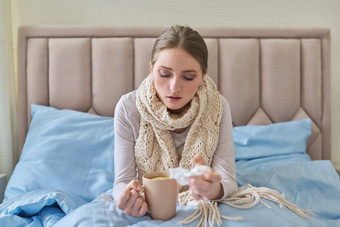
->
[169,165,211,186]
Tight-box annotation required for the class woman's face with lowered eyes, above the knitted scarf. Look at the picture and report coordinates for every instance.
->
[151,48,204,113]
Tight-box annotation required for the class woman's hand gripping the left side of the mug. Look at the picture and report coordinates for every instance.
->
[117,180,148,218]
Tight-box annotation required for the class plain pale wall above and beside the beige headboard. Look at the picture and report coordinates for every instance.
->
[12,0,340,168]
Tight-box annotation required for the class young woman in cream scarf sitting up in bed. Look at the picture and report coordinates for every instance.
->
[113,26,237,217]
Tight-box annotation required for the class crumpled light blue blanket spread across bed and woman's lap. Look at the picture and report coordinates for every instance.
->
[0,154,340,227]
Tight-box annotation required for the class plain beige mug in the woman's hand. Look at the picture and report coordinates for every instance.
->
[143,172,178,221]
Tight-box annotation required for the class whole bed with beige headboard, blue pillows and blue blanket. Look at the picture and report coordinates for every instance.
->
[0,26,340,226]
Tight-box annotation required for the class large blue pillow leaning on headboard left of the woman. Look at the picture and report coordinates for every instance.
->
[5,104,114,201]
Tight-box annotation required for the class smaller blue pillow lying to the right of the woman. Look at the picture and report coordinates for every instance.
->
[233,118,312,161]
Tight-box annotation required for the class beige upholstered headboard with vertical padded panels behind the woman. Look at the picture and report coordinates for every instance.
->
[18,26,331,159]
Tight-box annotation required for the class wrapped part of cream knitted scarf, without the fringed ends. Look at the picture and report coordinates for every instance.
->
[135,74,222,205]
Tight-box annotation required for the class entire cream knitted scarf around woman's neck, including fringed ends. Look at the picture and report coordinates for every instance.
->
[131,74,312,226]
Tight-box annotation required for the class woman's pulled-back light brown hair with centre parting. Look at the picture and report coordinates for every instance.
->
[151,25,208,75]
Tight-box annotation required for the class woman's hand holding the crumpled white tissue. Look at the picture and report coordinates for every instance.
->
[189,154,224,200]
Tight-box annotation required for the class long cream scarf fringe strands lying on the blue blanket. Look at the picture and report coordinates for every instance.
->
[178,185,314,227]
